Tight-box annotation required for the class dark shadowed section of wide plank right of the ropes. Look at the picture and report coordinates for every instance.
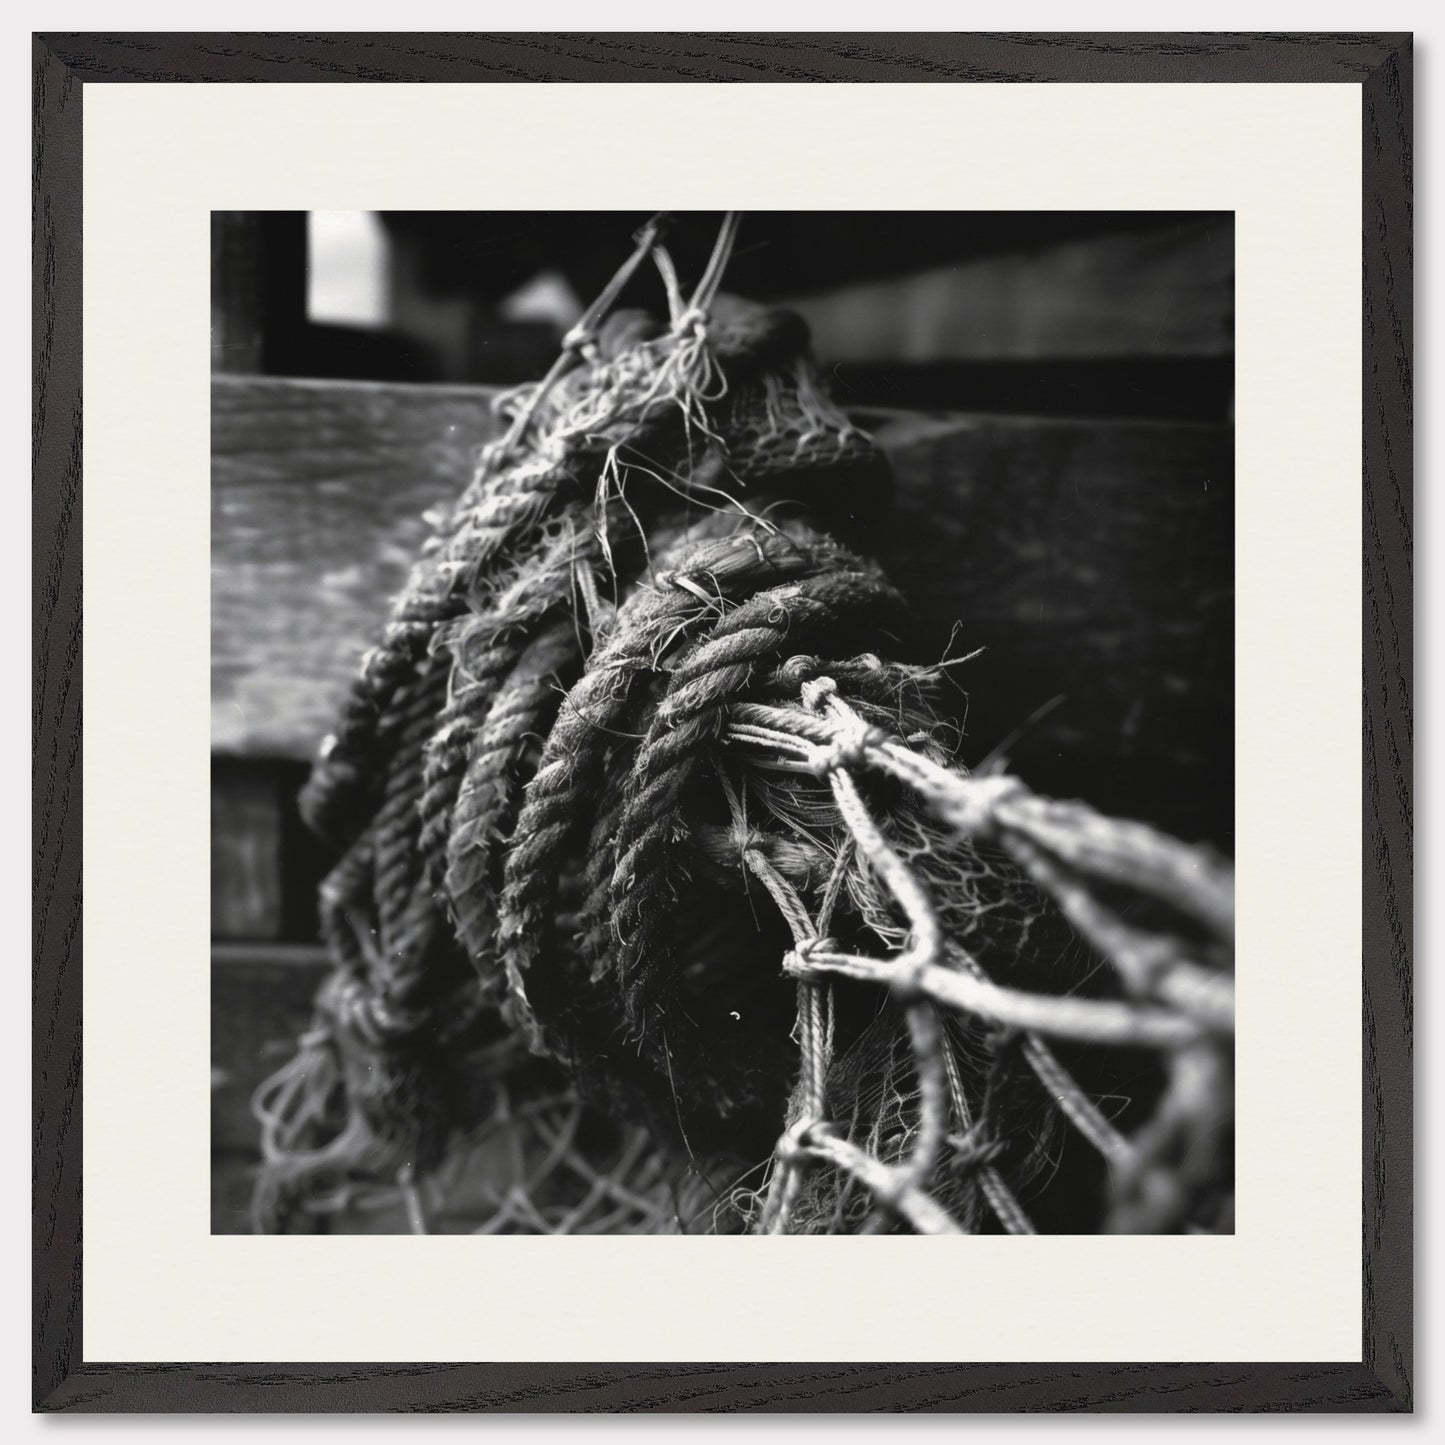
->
[877,419,1234,845]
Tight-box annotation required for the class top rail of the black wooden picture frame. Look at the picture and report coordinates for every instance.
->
[42,32,1400,84]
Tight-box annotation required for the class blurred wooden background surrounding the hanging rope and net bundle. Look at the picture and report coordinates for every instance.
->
[211,211,1234,1233]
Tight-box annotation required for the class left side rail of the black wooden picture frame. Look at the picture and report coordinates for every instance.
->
[30,31,82,1399]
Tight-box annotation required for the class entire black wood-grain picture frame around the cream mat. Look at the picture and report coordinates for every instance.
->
[32,33,1413,1412]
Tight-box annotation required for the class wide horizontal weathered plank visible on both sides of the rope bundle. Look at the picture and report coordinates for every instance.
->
[212,377,1233,842]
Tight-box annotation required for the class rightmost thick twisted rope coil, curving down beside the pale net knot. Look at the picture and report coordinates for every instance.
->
[611,558,903,1025]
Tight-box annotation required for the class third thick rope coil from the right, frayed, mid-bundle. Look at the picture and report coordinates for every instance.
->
[445,621,578,993]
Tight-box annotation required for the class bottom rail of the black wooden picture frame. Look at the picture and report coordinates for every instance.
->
[33,1364,1390,1415]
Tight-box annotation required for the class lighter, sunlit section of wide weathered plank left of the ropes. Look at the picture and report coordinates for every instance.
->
[211,377,493,757]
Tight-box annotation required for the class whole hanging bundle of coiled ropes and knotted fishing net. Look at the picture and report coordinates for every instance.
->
[254,217,1234,1234]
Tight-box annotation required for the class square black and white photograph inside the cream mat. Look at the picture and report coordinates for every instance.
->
[211,211,1234,1235]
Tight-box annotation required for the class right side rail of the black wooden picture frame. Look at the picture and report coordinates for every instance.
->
[1361,40,1415,1402]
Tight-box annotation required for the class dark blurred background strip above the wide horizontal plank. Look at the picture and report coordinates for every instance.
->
[212,211,1234,422]
